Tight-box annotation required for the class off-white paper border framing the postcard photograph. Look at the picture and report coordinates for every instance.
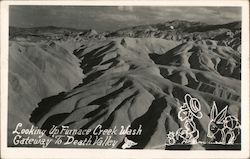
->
[1,0,250,159]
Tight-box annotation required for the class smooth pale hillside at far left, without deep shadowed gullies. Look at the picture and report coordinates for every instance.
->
[8,41,84,145]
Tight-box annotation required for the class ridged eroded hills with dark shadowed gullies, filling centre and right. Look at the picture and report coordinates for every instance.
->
[30,38,241,149]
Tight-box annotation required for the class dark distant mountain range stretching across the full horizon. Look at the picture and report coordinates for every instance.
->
[10,20,241,50]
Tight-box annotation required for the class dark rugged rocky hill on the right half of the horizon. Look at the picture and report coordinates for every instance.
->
[106,20,241,50]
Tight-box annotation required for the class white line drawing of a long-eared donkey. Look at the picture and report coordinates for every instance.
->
[207,102,240,144]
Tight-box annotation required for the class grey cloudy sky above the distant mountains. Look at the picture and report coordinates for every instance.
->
[9,5,241,32]
